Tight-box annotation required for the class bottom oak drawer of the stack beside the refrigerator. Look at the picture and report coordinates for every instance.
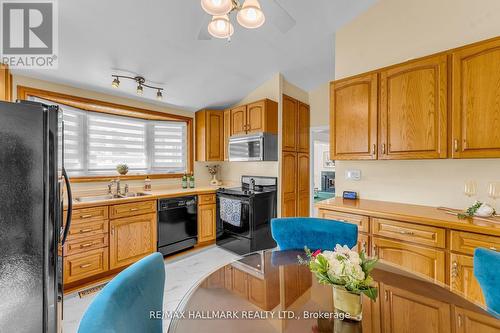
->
[64,247,108,283]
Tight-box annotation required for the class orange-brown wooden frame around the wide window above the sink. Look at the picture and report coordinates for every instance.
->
[17,86,194,183]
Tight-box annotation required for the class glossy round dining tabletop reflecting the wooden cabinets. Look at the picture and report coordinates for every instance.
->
[166,250,500,333]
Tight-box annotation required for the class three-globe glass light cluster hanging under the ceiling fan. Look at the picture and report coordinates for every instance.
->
[201,0,266,39]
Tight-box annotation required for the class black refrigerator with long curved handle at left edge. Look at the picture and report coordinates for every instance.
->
[0,101,71,333]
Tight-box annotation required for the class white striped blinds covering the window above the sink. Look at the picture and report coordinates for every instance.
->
[30,97,187,176]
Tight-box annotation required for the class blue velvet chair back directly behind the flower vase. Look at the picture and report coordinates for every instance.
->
[271,217,358,250]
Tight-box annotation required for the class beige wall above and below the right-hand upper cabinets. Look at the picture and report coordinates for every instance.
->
[335,0,500,209]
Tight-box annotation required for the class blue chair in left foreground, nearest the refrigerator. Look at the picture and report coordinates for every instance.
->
[78,252,165,333]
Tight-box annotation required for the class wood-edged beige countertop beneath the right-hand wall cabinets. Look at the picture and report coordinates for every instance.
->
[315,197,500,236]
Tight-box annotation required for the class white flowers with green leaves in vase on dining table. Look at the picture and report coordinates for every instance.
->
[299,244,378,321]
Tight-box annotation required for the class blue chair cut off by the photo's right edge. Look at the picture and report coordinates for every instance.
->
[474,247,500,319]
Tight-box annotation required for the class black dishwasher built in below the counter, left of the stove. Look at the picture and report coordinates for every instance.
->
[158,196,198,256]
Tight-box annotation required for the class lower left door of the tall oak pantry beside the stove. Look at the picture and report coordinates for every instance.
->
[281,152,297,217]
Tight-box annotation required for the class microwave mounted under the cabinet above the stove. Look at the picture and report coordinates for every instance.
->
[229,133,278,162]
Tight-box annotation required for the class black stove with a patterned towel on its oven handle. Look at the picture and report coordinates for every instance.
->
[217,176,278,254]
